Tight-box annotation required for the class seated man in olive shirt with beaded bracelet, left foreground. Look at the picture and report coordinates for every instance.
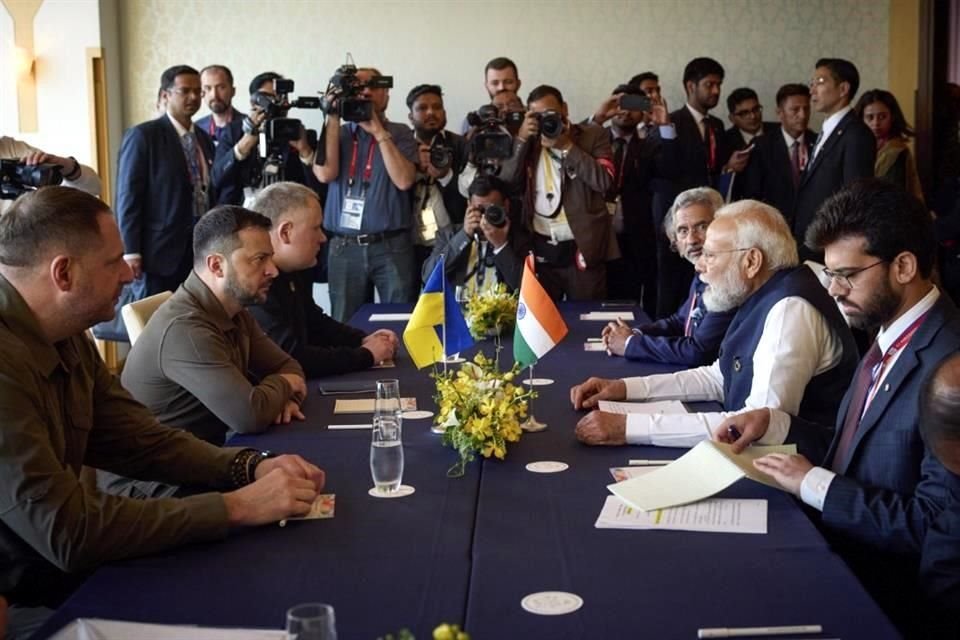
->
[0,187,324,638]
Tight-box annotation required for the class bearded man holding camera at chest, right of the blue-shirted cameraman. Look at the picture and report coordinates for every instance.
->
[407,84,467,273]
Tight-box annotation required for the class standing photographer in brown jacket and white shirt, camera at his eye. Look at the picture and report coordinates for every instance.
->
[502,85,620,300]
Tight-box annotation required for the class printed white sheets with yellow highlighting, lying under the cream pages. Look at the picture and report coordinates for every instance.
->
[594,496,767,533]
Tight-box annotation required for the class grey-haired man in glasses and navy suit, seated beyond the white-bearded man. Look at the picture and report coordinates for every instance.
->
[601,187,736,367]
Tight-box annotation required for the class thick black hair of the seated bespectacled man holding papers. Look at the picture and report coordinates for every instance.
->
[806,178,937,278]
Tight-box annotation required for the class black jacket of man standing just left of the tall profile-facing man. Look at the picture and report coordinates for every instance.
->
[737,127,817,221]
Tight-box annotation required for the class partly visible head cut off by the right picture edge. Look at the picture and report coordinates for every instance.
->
[920,353,960,457]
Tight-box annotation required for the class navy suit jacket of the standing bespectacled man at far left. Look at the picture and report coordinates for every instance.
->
[115,115,217,276]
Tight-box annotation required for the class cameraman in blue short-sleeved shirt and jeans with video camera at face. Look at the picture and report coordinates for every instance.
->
[313,65,418,322]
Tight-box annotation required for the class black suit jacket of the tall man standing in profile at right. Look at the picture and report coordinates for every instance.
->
[791,110,877,262]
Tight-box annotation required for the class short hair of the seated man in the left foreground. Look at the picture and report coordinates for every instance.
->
[0,187,110,267]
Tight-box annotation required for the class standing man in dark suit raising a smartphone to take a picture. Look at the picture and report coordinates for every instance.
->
[590,84,677,316]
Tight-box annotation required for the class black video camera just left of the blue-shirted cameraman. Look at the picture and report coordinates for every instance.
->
[250,78,320,187]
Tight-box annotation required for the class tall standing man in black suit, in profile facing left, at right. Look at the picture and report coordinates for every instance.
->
[790,58,877,262]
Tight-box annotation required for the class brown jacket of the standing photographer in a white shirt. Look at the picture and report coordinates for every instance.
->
[500,124,620,266]
